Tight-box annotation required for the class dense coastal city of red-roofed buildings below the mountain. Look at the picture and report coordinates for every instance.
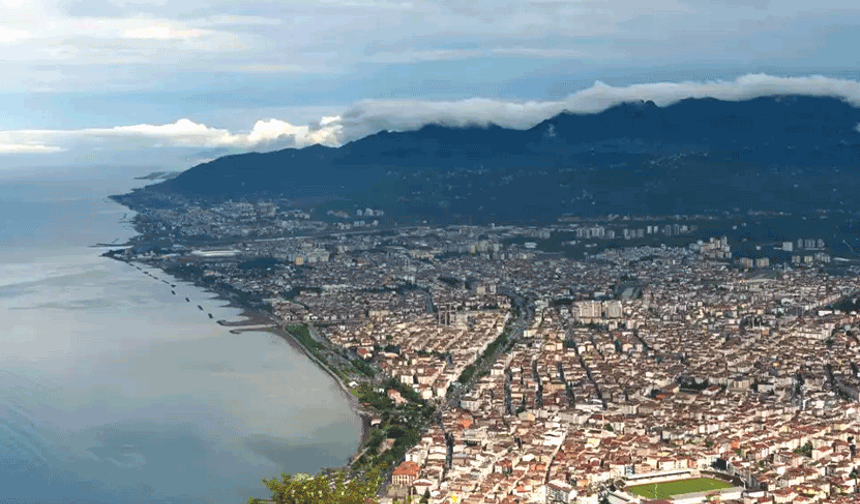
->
[109,197,860,504]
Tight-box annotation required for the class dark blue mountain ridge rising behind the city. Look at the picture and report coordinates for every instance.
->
[116,96,860,220]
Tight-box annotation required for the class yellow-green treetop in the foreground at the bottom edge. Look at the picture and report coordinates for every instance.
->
[248,471,382,504]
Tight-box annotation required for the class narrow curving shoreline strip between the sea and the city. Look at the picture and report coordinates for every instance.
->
[102,254,373,469]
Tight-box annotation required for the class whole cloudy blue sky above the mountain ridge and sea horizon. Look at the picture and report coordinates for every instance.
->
[0,0,860,170]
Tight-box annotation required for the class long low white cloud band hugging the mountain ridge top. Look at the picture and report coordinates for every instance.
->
[0,74,860,158]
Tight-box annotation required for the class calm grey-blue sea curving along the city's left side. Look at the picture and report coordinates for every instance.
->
[0,169,361,504]
